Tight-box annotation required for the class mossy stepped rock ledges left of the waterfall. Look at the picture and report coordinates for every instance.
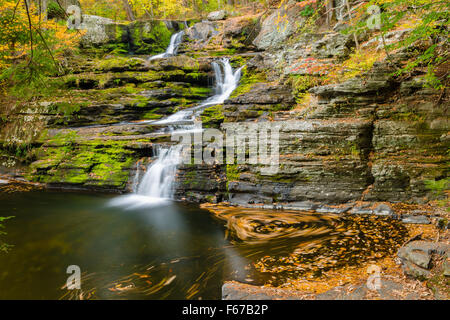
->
[1,56,211,192]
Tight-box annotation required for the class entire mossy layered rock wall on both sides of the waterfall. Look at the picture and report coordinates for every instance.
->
[0,9,450,205]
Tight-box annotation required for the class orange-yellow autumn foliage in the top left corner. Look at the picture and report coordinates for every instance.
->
[0,0,80,92]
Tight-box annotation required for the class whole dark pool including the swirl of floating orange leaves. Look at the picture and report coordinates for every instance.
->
[0,192,407,299]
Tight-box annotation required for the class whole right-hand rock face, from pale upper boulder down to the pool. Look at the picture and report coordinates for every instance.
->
[186,5,449,209]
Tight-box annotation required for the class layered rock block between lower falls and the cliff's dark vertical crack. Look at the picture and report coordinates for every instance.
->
[224,118,370,204]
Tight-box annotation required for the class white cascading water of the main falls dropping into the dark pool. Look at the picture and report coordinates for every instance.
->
[110,59,241,209]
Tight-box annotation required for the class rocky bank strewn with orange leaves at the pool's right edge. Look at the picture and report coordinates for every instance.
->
[202,203,450,300]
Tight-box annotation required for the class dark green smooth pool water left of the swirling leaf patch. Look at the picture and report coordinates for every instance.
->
[0,192,253,299]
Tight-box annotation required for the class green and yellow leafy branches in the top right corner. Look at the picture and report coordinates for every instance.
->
[345,0,450,89]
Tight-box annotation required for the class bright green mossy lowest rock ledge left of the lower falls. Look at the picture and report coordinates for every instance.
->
[26,132,137,189]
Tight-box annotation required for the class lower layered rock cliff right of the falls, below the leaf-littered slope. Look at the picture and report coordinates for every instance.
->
[218,51,448,204]
